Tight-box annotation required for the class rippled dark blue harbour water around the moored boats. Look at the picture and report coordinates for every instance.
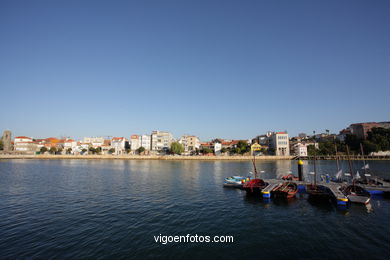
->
[0,160,390,259]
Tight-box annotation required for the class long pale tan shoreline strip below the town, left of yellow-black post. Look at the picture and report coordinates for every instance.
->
[0,154,294,161]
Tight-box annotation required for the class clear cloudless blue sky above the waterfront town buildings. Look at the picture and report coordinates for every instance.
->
[0,0,390,140]
